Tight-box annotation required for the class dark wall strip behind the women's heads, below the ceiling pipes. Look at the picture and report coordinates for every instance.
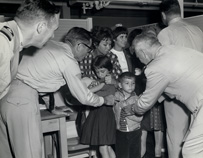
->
[71,8,161,27]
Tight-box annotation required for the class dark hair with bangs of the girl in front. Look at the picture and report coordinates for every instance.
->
[92,55,113,72]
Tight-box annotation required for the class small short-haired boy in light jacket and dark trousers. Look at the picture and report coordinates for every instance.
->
[114,72,142,158]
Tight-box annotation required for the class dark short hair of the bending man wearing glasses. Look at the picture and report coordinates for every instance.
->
[64,27,91,46]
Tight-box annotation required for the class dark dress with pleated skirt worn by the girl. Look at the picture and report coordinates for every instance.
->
[81,84,116,145]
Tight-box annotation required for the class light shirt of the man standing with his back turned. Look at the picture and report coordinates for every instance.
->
[158,17,203,52]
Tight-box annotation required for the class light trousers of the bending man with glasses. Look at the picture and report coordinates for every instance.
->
[0,80,42,158]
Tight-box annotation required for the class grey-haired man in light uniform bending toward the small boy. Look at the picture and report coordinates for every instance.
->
[129,34,203,158]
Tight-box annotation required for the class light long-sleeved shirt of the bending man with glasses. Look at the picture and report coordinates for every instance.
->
[17,41,104,106]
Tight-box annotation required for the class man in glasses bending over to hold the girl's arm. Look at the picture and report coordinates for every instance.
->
[0,27,112,158]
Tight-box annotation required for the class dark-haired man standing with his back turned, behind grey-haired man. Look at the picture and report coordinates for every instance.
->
[158,0,203,158]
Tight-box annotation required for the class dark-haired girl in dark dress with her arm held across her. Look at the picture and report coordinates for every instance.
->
[81,55,116,158]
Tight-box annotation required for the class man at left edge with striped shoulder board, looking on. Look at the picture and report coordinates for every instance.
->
[0,0,59,99]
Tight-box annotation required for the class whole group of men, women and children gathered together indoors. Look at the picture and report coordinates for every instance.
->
[0,0,203,158]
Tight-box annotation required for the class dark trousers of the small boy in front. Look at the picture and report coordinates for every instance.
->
[115,129,142,158]
